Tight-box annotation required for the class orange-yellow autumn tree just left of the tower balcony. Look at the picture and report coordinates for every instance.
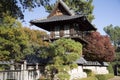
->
[22,27,49,54]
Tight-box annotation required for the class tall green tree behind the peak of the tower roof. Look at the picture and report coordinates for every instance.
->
[46,0,94,22]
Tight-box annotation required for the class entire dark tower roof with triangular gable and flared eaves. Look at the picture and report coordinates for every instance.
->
[30,0,97,31]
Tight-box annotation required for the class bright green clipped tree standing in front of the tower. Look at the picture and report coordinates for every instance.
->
[40,38,82,80]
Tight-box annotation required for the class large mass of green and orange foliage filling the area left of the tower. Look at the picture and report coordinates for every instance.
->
[0,14,47,60]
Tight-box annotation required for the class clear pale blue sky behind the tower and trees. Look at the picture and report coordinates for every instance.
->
[23,0,120,35]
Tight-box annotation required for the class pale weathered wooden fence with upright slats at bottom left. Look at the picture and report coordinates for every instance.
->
[0,70,40,80]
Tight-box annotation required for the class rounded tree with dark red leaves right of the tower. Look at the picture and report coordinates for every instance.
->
[83,32,115,62]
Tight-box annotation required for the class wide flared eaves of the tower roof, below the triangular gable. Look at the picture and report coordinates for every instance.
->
[30,15,96,31]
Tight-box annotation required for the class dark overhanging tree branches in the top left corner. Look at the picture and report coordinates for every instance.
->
[0,0,50,19]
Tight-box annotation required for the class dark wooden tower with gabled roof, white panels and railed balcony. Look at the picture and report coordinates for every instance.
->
[30,0,96,44]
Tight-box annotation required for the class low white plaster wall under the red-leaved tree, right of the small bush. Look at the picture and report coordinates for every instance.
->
[83,66,109,74]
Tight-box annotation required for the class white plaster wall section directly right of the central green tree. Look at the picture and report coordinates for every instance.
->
[69,66,87,80]
